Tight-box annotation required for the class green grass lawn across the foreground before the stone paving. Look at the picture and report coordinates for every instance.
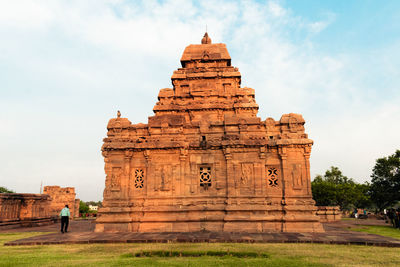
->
[0,233,400,267]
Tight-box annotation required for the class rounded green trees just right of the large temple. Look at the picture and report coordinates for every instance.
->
[311,166,370,210]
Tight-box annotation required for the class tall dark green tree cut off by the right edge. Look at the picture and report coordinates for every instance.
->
[370,150,400,211]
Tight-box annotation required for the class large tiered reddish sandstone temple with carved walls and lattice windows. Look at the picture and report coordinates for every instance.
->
[96,33,323,232]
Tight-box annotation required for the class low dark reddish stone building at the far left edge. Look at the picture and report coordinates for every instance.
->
[0,193,53,229]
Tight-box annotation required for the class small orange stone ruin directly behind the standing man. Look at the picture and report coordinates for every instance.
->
[43,186,79,218]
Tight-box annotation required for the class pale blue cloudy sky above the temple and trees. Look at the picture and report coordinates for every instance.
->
[0,0,400,201]
